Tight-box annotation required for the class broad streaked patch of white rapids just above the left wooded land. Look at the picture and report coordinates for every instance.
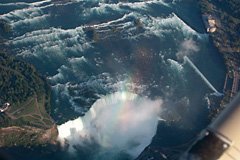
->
[8,27,91,57]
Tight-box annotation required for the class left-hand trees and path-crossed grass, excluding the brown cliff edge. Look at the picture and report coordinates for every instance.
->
[0,52,54,129]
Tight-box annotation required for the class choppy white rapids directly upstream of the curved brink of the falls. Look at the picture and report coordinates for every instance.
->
[48,72,146,113]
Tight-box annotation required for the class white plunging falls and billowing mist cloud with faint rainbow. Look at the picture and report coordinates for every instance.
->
[58,92,162,159]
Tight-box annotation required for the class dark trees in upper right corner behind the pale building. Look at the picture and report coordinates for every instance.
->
[199,0,240,60]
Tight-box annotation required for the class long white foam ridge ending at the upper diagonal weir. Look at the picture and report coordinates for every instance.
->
[91,12,206,39]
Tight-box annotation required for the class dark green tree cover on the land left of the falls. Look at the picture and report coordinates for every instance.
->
[0,52,48,104]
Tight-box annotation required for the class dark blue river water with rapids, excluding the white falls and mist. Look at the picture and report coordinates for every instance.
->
[0,0,225,160]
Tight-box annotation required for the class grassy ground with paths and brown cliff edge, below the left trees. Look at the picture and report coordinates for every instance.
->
[0,92,58,147]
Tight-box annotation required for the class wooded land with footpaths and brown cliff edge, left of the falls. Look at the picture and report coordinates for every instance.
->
[0,50,58,147]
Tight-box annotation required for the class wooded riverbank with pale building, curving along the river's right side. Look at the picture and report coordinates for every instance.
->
[199,0,240,114]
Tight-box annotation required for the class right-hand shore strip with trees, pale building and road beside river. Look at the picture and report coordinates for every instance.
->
[198,0,240,116]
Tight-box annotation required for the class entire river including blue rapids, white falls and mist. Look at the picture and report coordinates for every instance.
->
[0,0,224,160]
